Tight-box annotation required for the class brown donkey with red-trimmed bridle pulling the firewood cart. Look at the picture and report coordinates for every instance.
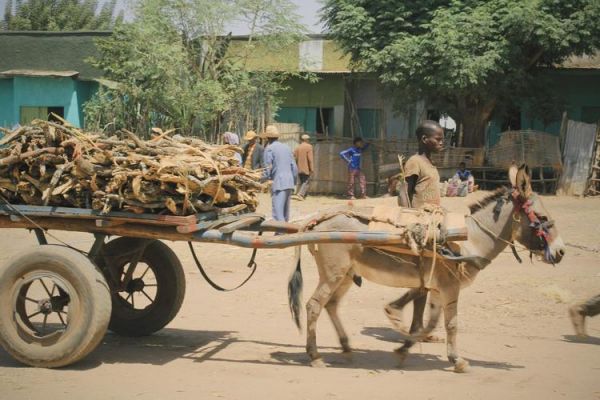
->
[288,165,565,372]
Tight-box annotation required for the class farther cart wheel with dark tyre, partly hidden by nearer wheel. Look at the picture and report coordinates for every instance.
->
[97,237,185,336]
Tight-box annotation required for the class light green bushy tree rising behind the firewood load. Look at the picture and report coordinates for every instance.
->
[85,0,310,141]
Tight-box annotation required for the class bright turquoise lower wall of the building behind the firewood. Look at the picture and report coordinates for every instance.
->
[0,76,98,127]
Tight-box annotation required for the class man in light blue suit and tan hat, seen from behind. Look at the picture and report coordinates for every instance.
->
[263,125,298,222]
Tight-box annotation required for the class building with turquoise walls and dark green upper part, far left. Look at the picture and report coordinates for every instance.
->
[0,32,110,127]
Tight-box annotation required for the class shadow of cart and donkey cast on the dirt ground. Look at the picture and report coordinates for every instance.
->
[0,328,523,371]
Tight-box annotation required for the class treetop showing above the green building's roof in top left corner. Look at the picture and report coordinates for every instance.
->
[3,0,123,31]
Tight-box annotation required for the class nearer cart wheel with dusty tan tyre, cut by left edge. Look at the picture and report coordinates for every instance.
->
[0,246,111,368]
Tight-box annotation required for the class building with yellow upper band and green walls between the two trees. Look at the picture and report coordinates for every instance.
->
[230,35,425,139]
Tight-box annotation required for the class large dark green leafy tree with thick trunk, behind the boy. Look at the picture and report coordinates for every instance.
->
[322,0,600,147]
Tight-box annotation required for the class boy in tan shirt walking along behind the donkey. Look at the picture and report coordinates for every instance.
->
[385,120,444,342]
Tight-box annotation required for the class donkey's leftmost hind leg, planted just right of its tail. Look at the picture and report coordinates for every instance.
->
[306,275,346,367]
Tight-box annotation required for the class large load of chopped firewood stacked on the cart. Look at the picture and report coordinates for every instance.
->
[0,120,264,215]
